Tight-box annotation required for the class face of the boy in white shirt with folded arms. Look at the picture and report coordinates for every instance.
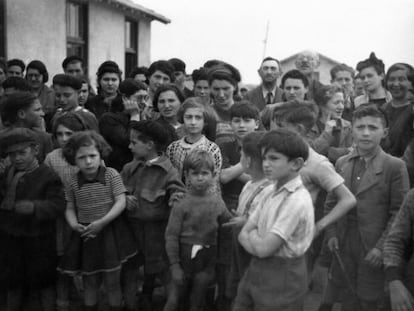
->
[262,149,300,184]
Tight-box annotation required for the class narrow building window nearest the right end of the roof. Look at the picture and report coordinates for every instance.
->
[125,20,138,76]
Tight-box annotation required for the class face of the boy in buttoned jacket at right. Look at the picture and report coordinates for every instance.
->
[352,116,387,152]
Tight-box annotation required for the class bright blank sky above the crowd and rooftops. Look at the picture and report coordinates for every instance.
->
[134,0,414,83]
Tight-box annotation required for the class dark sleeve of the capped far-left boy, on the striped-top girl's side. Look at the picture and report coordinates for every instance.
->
[33,175,65,220]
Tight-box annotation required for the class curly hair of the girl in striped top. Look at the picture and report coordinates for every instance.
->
[62,131,112,165]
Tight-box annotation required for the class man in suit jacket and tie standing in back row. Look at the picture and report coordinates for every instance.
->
[246,57,283,111]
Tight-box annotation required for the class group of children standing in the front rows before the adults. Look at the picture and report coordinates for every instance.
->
[0,61,414,311]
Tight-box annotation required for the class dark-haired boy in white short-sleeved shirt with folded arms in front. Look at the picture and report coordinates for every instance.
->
[233,129,314,311]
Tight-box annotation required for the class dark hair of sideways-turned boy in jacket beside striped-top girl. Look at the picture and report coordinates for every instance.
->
[129,120,168,152]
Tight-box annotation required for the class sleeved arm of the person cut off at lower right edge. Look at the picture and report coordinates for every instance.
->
[384,190,414,281]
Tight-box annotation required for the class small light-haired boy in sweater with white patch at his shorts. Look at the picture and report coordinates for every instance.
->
[164,149,231,311]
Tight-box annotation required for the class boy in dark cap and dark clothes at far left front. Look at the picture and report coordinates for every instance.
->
[0,128,65,311]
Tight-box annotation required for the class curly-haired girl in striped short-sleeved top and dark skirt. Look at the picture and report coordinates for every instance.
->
[58,131,136,311]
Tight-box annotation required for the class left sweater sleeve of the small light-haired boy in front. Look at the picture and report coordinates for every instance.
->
[165,204,184,265]
